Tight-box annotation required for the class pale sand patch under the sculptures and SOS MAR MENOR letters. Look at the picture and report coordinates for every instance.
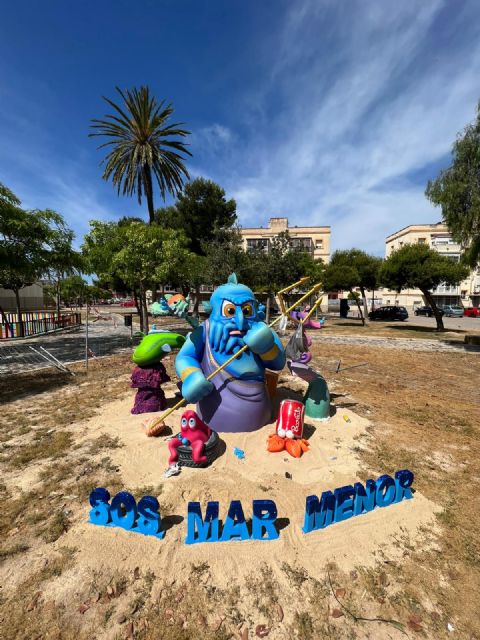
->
[45,370,436,597]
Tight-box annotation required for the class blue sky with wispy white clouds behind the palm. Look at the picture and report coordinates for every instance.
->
[0,0,480,255]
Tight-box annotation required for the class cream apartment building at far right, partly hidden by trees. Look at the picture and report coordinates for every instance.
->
[382,222,480,308]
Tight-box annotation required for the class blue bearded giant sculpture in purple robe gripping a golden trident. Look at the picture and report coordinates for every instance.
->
[175,274,285,432]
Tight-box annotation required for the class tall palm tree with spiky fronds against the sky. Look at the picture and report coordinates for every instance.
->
[89,87,192,223]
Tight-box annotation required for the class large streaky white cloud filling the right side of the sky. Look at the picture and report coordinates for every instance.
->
[202,1,480,253]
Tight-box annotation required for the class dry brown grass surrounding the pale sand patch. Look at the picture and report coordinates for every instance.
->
[0,344,480,640]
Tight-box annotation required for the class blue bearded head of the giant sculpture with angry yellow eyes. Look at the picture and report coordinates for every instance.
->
[209,276,260,354]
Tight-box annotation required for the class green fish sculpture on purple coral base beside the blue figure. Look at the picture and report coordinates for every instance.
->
[130,332,185,414]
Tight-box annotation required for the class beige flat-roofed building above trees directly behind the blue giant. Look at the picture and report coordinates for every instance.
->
[240,218,330,263]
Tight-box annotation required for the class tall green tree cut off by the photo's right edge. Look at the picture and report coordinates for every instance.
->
[425,103,480,267]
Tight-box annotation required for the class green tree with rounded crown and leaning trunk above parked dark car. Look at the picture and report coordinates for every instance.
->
[379,244,468,331]
